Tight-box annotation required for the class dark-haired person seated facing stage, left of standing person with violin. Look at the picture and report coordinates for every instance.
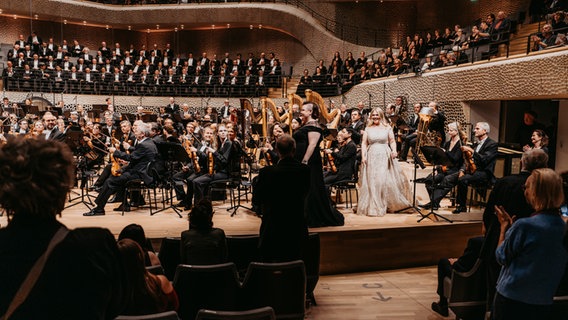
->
[180,200,228,265]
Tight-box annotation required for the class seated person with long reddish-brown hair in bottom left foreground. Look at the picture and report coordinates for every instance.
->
[118,239,179,315]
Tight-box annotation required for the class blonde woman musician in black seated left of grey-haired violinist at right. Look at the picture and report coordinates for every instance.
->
[420,122,467,210]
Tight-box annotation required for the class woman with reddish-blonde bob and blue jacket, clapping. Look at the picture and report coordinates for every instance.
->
[493,169,568,320]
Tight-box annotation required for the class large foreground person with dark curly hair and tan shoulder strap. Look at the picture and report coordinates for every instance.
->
[0,136,125,319]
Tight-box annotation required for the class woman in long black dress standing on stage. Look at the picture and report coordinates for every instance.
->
[294,102,344,228]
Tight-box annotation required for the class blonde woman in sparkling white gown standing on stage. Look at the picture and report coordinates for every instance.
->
[357,108,412,216]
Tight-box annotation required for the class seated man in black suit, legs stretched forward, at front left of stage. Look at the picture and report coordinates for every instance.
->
[83,122,158,216]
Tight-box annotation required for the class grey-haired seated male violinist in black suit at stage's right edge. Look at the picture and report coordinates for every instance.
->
[432,122,498,213]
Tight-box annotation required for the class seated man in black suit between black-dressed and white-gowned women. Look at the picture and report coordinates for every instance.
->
[323,128,357,189]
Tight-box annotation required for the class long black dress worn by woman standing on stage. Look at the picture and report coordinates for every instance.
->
[294,125,344,228]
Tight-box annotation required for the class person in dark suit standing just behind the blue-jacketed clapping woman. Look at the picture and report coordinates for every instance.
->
[483,149,548,312]
